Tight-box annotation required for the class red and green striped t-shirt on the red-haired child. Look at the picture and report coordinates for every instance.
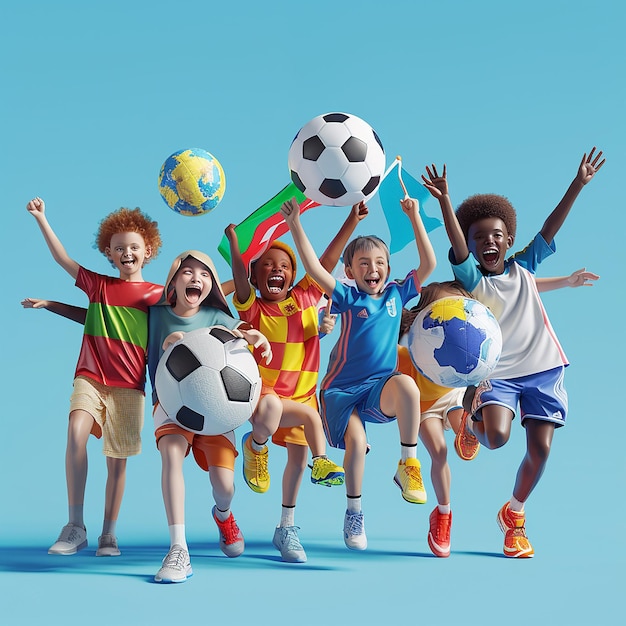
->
[76,267,163,391]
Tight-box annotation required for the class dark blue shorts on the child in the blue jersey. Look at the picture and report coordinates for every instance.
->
[320,372,400,450]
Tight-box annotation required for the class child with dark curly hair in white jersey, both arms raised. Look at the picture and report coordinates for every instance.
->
[422,147,605,558]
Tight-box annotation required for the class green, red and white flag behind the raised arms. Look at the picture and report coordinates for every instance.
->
[217,183,320,267]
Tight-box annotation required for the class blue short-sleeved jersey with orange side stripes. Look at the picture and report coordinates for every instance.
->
[321,270,421,389]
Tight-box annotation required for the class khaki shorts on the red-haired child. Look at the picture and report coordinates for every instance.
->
[70,376,145,459]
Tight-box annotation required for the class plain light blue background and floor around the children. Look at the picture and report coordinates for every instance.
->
[0,0,626,625]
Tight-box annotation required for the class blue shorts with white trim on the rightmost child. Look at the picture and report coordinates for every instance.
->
[472,367,567,427]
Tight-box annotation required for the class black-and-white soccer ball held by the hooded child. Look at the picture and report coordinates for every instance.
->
[155,326,261,435]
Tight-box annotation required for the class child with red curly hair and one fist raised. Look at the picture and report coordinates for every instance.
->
[26,198,163,556]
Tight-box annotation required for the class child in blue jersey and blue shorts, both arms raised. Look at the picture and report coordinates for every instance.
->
[281,198,436,550]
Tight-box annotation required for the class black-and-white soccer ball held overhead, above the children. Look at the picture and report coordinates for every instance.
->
[288,113,385,206]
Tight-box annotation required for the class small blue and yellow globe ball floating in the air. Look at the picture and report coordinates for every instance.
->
[159,148,226,216]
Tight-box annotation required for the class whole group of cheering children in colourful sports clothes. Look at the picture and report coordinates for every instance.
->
[23,148,604,582]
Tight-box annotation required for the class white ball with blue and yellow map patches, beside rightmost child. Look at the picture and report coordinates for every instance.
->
[408,297,502,387]
